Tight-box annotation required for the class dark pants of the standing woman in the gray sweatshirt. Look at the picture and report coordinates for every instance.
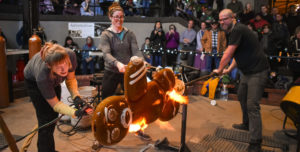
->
[102,70,124,100]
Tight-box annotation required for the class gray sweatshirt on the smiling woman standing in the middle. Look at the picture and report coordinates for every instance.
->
[98,27,143,73]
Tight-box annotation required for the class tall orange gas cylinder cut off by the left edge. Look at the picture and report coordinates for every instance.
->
[0,36,9,108]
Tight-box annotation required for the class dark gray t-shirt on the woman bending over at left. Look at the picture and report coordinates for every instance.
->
[24,49,77,99]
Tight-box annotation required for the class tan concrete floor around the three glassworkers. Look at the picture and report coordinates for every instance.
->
[1,96,296,152]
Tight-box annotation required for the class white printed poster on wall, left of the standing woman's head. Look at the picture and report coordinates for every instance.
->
[68,22,95,38]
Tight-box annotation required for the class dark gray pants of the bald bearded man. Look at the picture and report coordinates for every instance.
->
[238,70,268,143]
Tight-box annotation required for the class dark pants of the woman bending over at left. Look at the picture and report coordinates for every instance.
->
[25,80,61,152]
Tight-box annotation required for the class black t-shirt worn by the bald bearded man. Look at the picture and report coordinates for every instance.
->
[228,23,269,74]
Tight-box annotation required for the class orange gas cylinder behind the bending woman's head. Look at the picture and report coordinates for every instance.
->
[28,29,42,60]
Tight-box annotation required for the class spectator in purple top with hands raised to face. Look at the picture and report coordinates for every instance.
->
[166,24,180,66]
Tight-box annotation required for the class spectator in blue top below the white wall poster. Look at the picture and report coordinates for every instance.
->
[81,36,97,74]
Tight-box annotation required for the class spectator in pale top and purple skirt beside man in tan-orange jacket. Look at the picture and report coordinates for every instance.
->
[194,22,207,72]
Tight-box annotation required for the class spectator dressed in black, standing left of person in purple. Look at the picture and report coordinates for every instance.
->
[150,21,166,66]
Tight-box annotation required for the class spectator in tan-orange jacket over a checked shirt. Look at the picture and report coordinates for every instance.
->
[201,20,226,72]
